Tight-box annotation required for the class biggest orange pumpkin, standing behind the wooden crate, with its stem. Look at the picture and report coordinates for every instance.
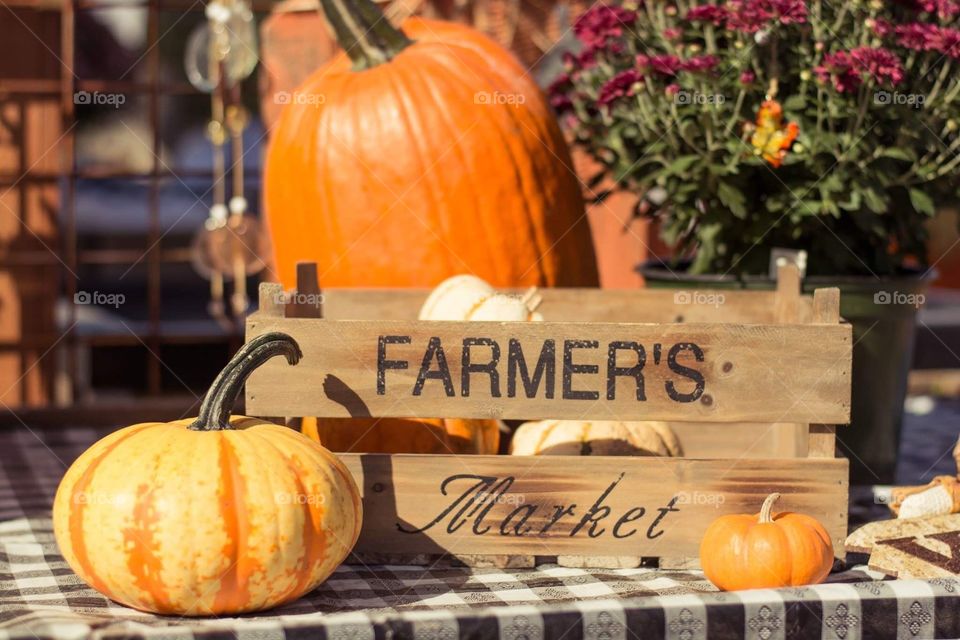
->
[264,0,598,288]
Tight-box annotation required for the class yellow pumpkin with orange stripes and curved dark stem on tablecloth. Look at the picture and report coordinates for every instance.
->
[53,333,361,615]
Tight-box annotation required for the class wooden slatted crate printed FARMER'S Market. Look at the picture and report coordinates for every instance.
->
[246,265,852,566]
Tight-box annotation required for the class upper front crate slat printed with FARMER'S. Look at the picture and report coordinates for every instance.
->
[247,316,852,423]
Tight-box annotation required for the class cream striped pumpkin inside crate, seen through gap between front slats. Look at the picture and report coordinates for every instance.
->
[510,420,683,457]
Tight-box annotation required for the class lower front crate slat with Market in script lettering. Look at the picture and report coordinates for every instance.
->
[341,454,847,557]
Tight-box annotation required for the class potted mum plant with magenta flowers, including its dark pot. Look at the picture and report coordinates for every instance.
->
[550,0,960,483]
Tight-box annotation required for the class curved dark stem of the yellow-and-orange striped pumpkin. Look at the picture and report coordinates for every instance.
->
[188,332,303,431]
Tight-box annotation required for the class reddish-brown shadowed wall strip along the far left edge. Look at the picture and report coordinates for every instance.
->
[0,8,62,407]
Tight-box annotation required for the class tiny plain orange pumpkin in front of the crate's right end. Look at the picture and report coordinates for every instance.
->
[700,493,833,591]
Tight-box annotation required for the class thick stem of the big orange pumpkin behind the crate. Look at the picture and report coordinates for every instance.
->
[320,0,413,71]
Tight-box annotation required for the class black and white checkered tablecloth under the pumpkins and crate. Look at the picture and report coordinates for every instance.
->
[0,428,960,640]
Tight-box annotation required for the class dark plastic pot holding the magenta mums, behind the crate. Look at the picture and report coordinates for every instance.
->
[637,260,935,484]
